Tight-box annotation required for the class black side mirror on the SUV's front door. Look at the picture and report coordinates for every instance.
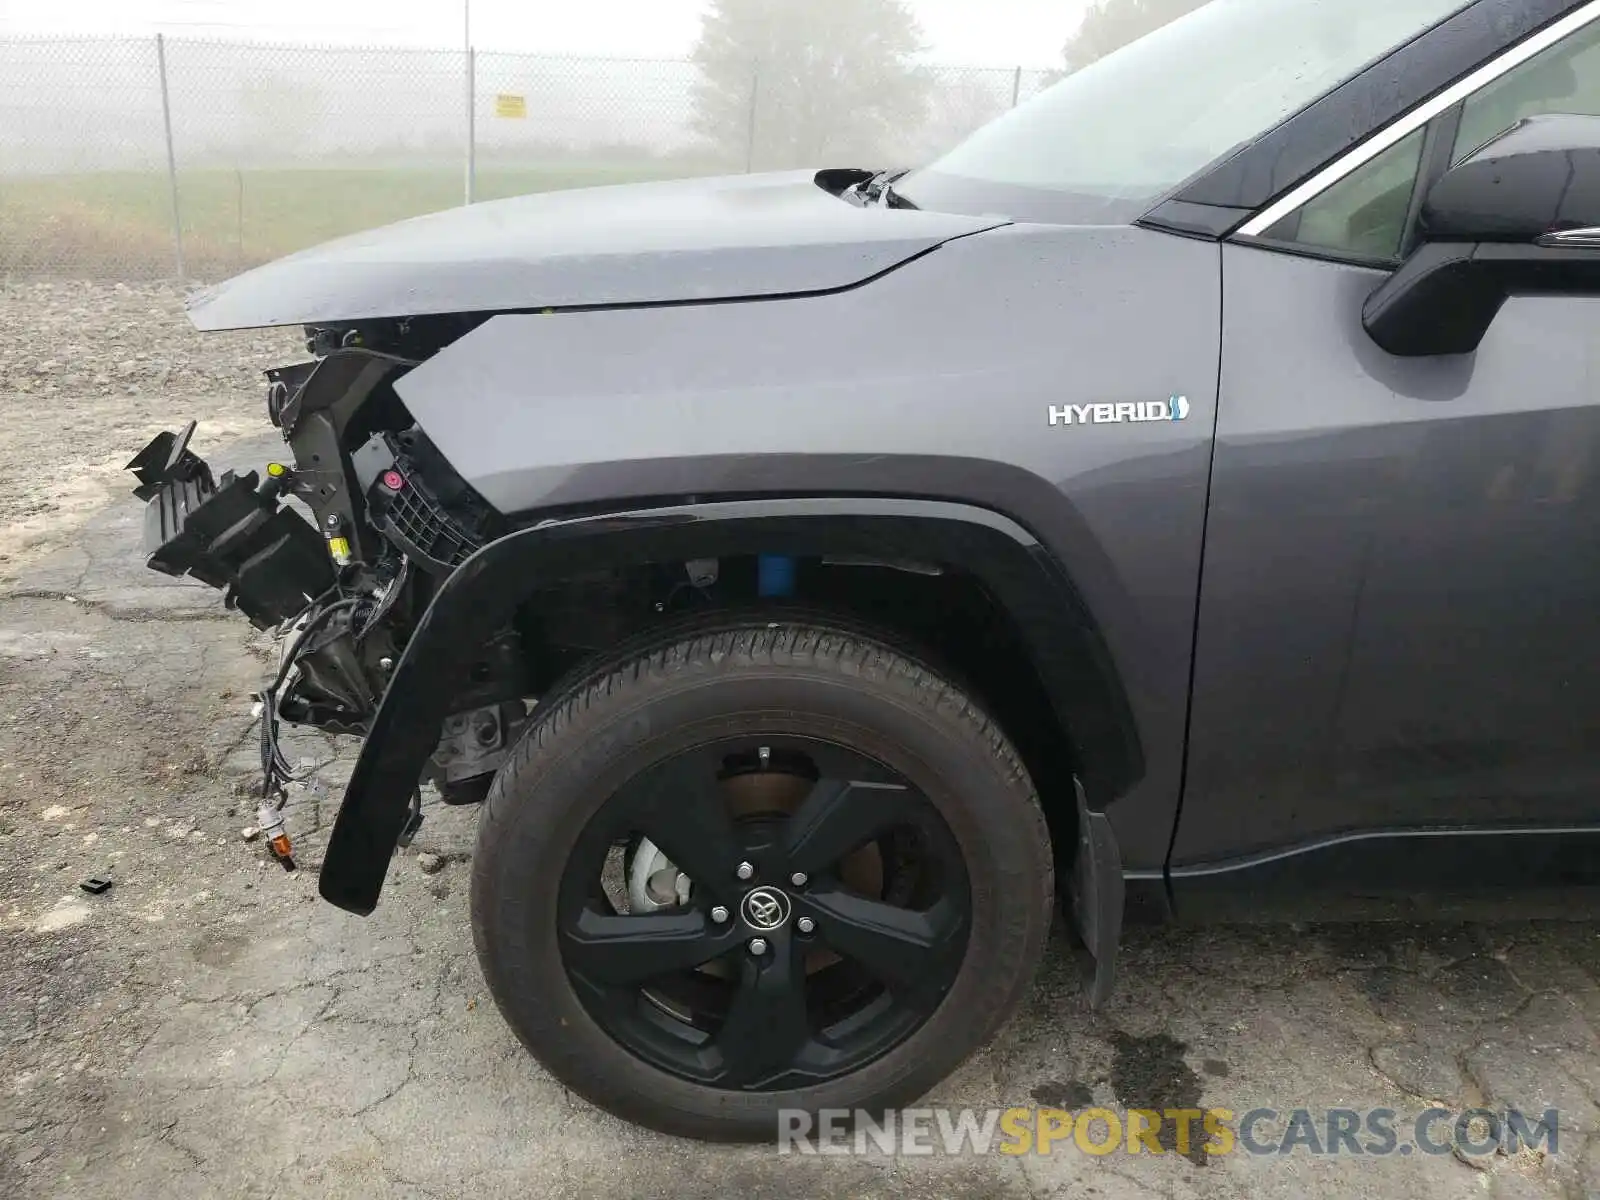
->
[1362,114,1600,357]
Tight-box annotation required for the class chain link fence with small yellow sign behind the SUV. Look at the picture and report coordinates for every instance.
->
[0,38,1051,282]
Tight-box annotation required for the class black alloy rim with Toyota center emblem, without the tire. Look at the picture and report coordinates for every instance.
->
[558,738,970,1091]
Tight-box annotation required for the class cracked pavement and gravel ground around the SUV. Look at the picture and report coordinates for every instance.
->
[0,285,1600,1200]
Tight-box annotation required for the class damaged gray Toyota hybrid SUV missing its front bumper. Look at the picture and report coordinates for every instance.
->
[131,0,1600,1138]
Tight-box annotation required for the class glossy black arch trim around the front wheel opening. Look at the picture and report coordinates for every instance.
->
[318,498,1144,915]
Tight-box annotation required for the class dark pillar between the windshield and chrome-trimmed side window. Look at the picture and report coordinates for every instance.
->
[1139,0,1584,238]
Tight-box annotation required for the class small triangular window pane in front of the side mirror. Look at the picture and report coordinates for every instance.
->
[1264,130,1424,259]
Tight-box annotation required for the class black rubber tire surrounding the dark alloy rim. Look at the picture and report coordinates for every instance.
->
[472,618,1054,1141]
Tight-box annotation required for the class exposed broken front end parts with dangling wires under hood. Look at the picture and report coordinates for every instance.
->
[128,322,528,869]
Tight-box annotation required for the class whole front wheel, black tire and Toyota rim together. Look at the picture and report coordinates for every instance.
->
[472,622,1053,1141]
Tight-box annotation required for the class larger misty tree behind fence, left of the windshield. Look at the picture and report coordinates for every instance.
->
[694,0,930,166]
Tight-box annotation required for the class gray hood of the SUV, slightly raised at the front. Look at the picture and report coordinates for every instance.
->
[189,171,1006,330]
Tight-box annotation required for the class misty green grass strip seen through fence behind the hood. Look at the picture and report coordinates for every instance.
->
[0,158,717,278]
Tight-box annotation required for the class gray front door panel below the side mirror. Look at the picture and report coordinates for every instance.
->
[1171,245,1600,870]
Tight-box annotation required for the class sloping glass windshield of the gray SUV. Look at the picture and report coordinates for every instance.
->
[894,0,1466,224]
